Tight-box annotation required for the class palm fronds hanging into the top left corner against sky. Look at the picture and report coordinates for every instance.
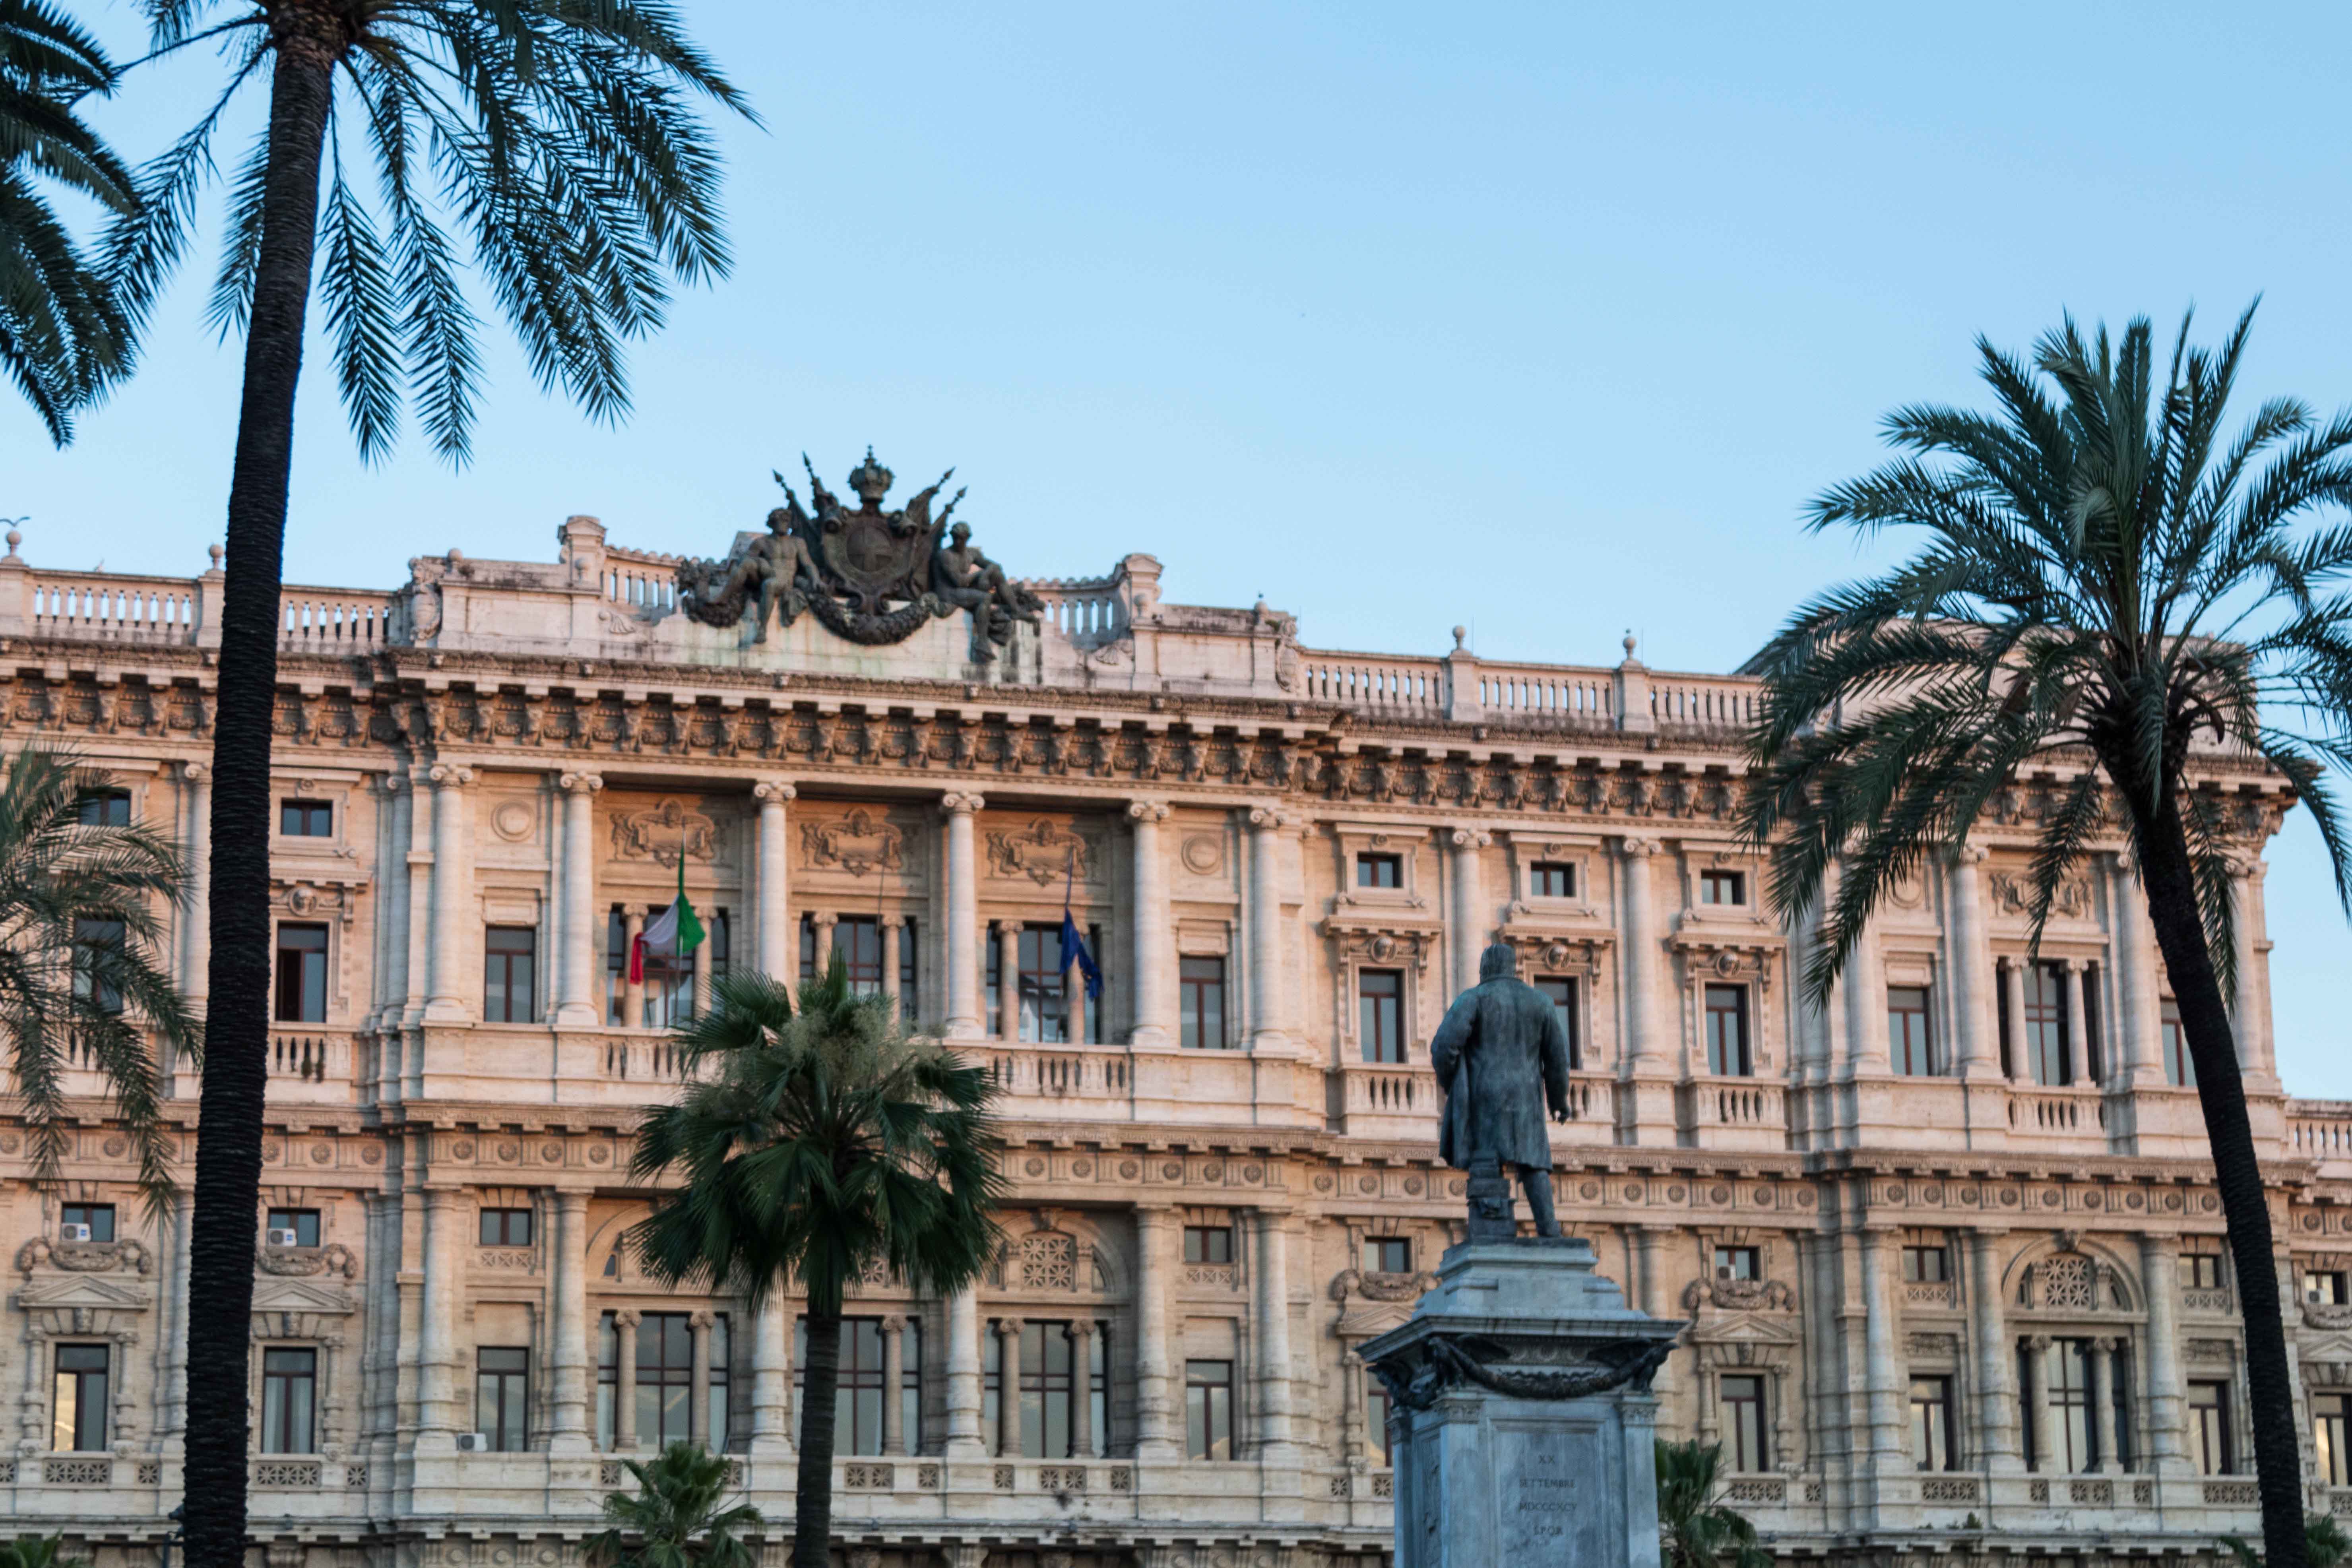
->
[0,0,139,447]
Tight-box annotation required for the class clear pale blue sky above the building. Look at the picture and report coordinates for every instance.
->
[14,0,2352,1098]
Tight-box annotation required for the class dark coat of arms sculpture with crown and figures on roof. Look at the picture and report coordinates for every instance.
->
[677,447,1044,663]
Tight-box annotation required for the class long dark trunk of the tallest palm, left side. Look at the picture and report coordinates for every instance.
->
[186,27,341,1568]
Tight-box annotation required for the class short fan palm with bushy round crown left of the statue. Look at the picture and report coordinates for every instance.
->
[630,959,1004,1568]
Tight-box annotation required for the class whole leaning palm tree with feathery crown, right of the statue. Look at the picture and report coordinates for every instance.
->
[1743,308,2352,1568]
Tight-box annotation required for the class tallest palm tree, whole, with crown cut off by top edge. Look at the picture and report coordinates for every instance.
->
[108,0,748,1568]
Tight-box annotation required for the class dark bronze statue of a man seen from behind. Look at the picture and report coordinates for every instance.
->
[1430,943,1569,1241]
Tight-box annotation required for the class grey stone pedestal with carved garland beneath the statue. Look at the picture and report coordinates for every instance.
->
[1364,1239,1682,1568]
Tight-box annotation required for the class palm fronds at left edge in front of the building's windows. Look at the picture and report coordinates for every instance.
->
[0,745,202,1208]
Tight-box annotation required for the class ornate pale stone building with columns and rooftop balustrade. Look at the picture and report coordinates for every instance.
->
[0,463,2352,1568]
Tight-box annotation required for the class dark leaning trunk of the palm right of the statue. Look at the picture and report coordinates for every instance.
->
[2140,790,2305,1568]
